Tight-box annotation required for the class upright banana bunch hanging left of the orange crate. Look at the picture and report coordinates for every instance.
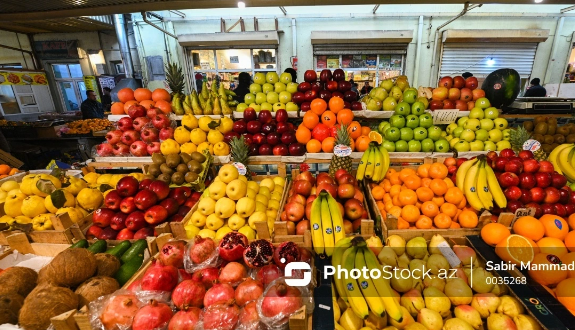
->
[310,191,345,256]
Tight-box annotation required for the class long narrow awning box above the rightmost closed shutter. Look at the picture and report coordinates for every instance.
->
[443,29,549,43]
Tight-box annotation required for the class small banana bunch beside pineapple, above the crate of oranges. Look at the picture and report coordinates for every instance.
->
[356,142,390,182]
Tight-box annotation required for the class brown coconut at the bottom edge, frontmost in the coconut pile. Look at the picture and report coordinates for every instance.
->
[18,282,78,330]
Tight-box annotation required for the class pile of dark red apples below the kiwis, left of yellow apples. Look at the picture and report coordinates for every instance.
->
[86,176,200,240]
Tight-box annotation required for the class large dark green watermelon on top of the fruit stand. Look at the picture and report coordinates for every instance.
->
[481,69,521,109]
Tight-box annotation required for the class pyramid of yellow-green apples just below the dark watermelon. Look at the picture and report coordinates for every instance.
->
[446,102,510,152]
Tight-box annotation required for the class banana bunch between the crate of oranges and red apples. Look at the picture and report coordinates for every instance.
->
[455,156,507,211]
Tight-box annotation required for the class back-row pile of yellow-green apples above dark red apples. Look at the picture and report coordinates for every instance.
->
[236,72,300,112]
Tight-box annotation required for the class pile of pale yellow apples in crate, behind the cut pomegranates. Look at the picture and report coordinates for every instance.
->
[184,164,285,242]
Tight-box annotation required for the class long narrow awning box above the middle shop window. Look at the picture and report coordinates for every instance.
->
[311,30,413,45]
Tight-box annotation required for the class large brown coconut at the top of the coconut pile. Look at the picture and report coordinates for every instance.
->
[38,249,97,287]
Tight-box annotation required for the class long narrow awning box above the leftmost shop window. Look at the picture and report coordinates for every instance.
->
[178,31,280,48]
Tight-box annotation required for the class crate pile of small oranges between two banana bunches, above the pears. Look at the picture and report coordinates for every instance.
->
[370,163,479,229]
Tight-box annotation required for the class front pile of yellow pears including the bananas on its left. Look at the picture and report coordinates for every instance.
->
[332,235,541,330]
